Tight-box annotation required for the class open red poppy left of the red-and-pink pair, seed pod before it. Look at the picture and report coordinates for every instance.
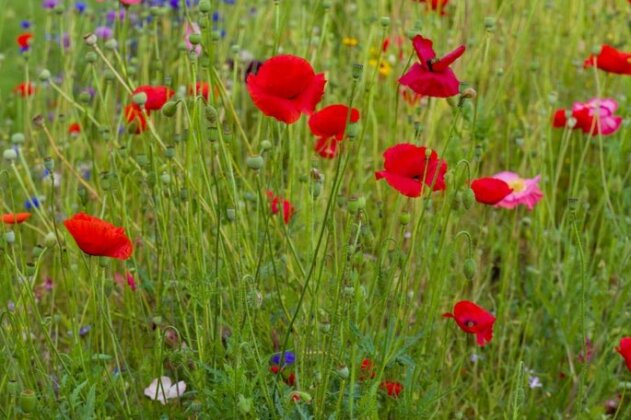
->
[375,143,447,197]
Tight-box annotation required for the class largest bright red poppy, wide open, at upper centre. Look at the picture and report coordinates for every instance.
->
[247,55,326,124]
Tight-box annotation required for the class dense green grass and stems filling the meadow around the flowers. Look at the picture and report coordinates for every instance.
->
[0,0,631,419]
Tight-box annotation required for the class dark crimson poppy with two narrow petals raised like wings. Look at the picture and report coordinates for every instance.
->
[399,35,465,98]
